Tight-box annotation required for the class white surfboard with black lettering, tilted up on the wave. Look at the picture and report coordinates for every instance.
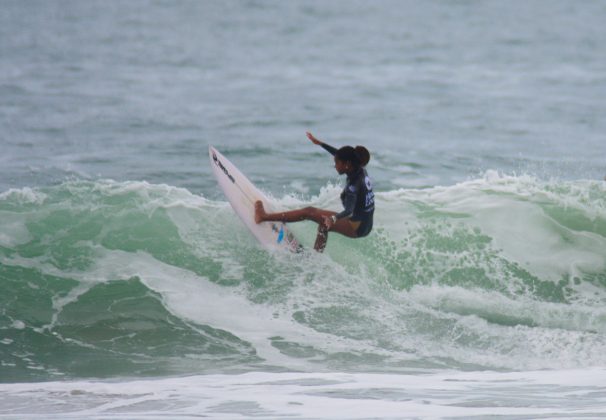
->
[208,146,301,252]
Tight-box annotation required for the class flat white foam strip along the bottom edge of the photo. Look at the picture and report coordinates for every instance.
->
[0,368,606,419]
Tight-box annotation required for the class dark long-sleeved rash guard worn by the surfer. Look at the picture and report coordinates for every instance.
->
[321,143,375,237]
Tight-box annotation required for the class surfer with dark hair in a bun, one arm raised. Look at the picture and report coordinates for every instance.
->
[255,132,375,252]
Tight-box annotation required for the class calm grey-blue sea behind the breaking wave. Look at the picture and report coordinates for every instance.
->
[0,0,606,198]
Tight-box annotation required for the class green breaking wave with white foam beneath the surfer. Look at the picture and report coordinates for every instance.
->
[0,172,606,382]
